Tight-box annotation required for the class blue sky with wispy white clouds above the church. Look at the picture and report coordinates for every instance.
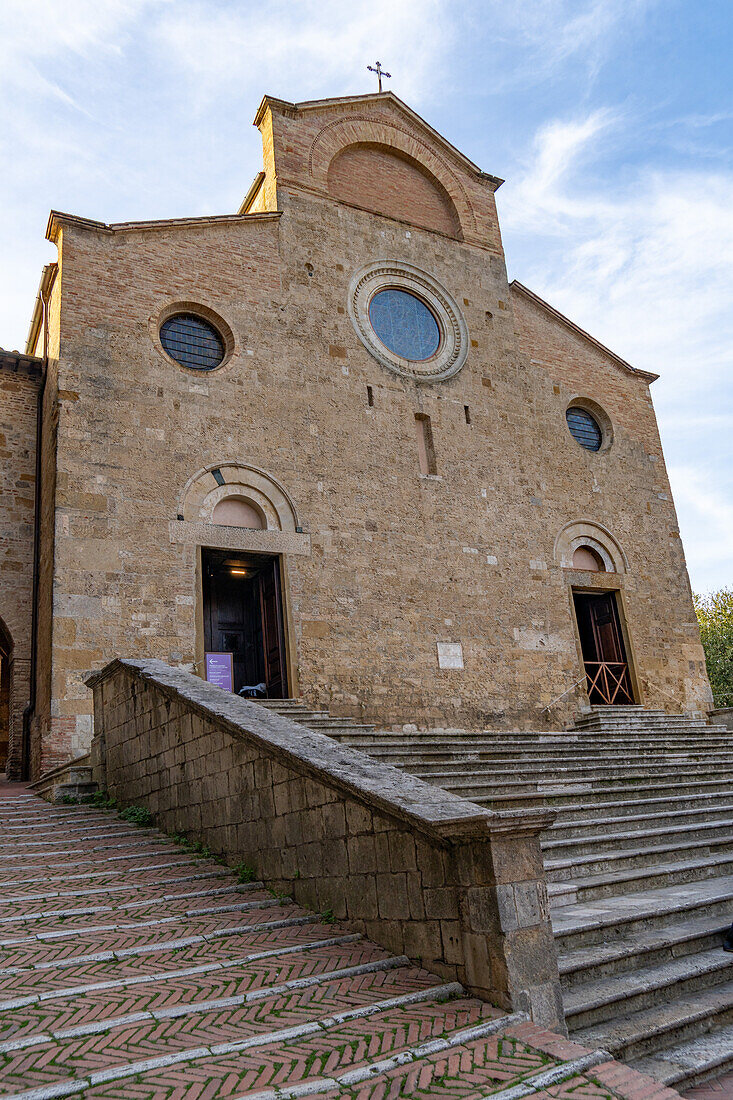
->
[0,0,733,591]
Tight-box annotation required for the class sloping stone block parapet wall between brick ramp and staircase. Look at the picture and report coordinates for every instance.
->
[90,661,565,1031]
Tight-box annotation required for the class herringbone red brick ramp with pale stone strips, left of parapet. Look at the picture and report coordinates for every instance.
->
[0,784,686,1100]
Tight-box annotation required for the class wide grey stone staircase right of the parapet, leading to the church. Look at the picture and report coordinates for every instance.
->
[327,707,733,1089]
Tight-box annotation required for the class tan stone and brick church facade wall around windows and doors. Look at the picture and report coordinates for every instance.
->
[32,92,709,774]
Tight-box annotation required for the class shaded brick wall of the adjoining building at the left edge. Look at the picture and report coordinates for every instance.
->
[0,355,41,778]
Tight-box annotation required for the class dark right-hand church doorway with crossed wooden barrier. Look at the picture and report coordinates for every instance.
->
[572,592,634,705]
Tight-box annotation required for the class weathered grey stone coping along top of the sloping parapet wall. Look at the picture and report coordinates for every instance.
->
[86,658,556,844]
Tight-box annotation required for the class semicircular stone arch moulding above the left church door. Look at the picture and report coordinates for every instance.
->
[177,461,300,534]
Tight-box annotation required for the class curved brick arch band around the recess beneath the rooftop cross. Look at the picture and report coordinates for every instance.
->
[308,114,477,235]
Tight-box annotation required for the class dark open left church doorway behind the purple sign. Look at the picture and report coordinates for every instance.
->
[201,550,287,699]
